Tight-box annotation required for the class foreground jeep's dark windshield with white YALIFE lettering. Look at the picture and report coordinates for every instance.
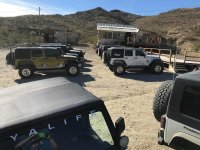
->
[0,111,114,150]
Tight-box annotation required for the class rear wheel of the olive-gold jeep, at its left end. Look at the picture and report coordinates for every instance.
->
[18,65,34,79]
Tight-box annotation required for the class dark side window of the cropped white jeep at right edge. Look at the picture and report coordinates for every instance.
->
[180,86,200,120]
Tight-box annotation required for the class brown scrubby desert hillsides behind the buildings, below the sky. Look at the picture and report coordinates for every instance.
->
[0,8,200,51]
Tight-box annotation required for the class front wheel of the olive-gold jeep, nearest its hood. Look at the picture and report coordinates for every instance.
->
[66,63,80,76]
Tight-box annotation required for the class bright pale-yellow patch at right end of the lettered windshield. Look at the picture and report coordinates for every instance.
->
[89,112,114,145]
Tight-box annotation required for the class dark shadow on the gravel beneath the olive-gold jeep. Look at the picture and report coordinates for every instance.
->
[15,72,95,87]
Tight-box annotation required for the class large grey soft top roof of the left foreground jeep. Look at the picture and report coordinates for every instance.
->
[0,77,103,133]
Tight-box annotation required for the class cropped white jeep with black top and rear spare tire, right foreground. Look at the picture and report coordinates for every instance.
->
[153,71,200,150]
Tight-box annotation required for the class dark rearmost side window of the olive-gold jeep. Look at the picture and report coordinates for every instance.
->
[15,49,31,59]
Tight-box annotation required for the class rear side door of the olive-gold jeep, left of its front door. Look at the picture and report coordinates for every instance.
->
[31,49,44,69]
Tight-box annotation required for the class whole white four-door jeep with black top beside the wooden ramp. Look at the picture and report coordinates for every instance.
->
[104,47,164,75]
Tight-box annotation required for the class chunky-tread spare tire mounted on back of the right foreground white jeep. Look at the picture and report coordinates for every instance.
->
[153,80,174,121]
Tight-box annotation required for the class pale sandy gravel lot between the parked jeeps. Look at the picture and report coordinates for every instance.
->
[0,47,173,150]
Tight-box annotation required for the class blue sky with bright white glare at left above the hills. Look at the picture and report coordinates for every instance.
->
[0,0,200,17]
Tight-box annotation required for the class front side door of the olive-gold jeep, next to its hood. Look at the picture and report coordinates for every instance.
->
[43,49,62,69]
